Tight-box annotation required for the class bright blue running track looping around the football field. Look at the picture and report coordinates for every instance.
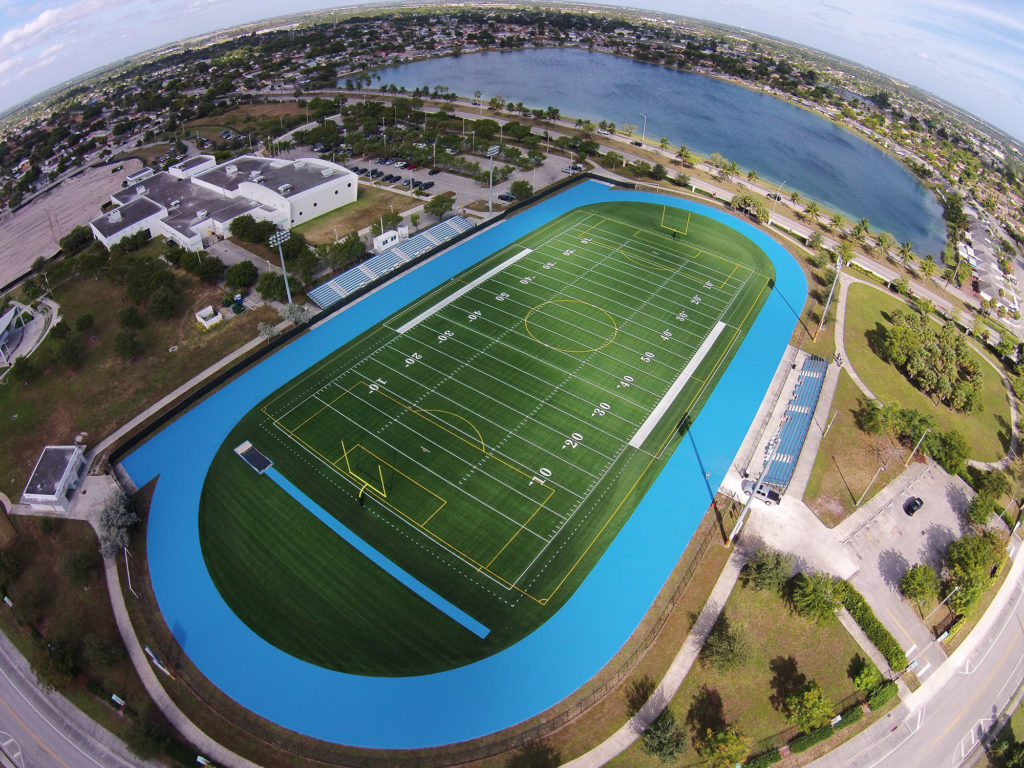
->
[122,181,807,749]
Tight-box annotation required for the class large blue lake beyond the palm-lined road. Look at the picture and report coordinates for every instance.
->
[368,48,945,256]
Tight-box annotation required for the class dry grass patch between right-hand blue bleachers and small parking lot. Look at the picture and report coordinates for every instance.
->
[804,369,908,527]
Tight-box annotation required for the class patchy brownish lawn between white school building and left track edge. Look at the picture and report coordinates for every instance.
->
[0,273,276,500]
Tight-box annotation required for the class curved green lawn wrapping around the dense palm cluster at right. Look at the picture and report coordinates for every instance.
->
[845,284,1010,462]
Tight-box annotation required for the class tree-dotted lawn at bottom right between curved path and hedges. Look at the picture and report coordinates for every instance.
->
[608,584,863,768]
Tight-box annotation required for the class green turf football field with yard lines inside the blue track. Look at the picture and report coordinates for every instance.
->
[200,203,774,675]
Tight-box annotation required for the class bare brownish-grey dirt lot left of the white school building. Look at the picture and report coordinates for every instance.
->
[0,160,142,286]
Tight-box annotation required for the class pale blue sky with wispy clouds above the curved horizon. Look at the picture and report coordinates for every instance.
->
[0,0,1024,140]
